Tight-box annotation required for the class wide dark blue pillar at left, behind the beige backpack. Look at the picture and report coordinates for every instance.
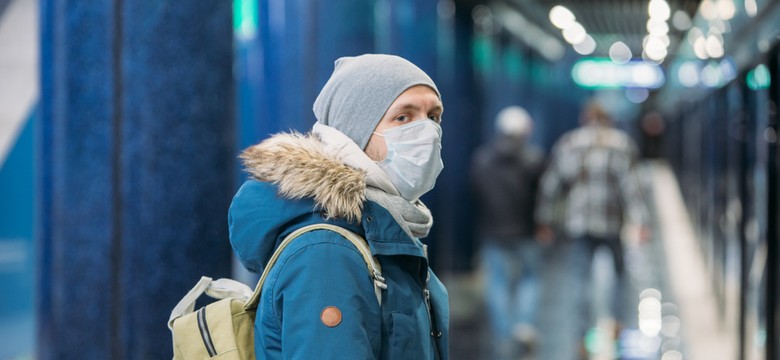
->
[36,0,235,359]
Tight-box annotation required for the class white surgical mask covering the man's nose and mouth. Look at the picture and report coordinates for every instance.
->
[374,120,444,201]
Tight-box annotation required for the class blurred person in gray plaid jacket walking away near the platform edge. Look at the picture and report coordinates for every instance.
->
[536,102,648,357]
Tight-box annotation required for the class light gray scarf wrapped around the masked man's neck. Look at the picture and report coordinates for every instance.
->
[312,123,433,238]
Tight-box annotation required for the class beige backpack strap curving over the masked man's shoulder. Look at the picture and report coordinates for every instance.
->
[244,223,387,310]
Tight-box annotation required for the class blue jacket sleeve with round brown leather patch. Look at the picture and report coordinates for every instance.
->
[269,230,381,359]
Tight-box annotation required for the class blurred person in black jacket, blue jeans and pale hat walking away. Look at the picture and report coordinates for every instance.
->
[471,106,543,359]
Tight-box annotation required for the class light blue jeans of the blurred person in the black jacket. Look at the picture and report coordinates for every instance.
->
[481,239,542,357]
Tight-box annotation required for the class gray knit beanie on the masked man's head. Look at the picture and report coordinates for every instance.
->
[314,54,441,149]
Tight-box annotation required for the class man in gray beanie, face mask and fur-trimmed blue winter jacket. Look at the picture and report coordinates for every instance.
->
[229,54,449,359]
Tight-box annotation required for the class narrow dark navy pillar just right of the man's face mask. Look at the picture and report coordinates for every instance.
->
[424,1,483,272]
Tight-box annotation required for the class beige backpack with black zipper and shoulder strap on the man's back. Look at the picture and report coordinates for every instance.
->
[168,224,387,360]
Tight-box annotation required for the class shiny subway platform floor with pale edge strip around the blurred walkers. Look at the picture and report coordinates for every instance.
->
[444,162,737,360]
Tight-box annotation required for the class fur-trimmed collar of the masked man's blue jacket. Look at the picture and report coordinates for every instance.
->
[240,133,425,257]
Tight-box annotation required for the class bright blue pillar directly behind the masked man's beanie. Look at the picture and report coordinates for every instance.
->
[240,0,374,142]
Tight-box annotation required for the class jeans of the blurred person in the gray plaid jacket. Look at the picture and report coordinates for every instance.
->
[569,235,627,335]
